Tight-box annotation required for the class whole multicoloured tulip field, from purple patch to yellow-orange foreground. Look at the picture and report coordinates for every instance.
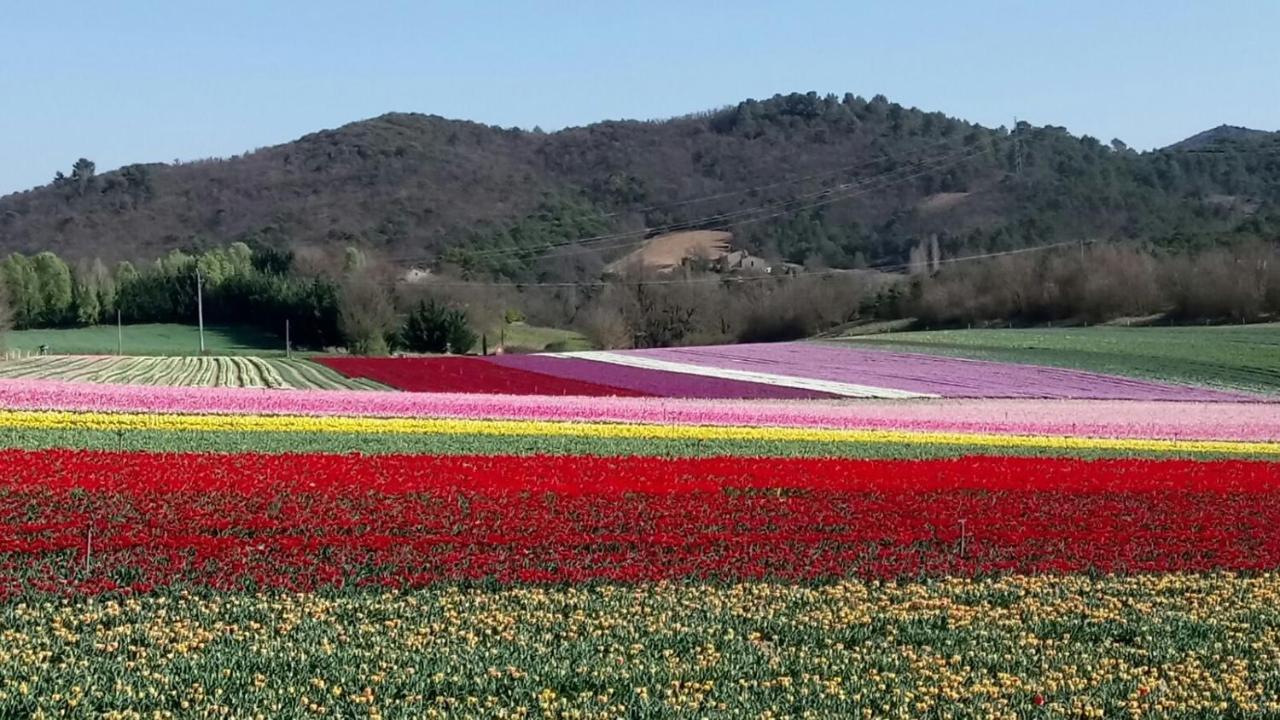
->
[0,342,1280,719]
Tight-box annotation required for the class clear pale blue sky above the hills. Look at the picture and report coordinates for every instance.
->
[0,0,1280,195]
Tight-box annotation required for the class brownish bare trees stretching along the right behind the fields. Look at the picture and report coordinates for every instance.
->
[414,238,1280,348]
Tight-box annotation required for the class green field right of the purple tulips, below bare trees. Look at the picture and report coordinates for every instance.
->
[833,324,1280,395]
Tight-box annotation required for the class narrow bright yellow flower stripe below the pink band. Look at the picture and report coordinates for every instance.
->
[0,410,1280,455]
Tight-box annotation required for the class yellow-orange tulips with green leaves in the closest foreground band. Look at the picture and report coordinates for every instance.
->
[0,574,1280,720]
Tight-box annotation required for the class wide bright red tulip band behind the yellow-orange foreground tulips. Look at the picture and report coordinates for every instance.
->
[0,450,1280,594]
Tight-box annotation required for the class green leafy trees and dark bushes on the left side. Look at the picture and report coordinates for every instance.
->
[0,242,475,355]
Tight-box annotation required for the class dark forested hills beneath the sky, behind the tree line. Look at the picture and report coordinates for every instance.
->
[0,94,1280,281]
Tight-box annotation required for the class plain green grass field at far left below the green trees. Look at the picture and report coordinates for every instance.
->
[3,324,284,356]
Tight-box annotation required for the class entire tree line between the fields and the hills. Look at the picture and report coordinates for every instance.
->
[0,241,1280,355]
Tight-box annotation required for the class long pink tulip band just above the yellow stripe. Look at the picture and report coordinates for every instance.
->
[0,380,1280,441]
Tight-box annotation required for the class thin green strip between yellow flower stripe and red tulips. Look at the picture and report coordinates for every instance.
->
[0,429,1275,461]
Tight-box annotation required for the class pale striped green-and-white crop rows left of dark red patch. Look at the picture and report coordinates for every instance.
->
[0,355,387,389]
